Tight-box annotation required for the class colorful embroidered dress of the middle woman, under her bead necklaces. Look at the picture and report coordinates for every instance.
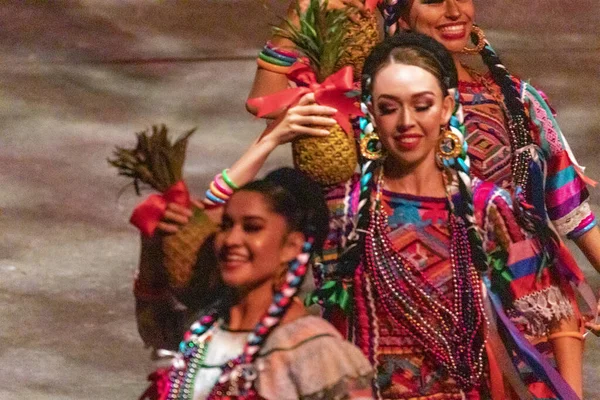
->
[317,180,573,400]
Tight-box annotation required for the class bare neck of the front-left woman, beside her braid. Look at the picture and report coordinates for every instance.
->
[229,280,273,330]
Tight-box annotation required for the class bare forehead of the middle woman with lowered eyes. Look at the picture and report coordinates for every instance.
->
[373,64,442,97]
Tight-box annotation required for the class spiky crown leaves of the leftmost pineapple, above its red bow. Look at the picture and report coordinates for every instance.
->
[107,124,196,195]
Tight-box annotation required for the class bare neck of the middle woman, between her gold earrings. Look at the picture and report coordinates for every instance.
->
[383,157,446,197]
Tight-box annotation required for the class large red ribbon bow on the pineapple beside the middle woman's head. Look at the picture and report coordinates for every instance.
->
[248,60,364,134]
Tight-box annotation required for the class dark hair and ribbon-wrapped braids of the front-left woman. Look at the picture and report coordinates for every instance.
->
[164,168,329,399]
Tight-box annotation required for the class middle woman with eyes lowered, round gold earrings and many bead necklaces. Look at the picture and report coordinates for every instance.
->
[315,34,582,400]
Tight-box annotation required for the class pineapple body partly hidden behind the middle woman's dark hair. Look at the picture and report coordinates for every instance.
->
[336,6,381,81]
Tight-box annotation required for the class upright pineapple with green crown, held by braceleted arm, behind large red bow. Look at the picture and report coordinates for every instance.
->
[274,0,358,186]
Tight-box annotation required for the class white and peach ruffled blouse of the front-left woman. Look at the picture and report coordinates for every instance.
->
[142,315,372,400]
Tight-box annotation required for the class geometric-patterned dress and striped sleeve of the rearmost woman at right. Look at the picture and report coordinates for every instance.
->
[459,74,596,238]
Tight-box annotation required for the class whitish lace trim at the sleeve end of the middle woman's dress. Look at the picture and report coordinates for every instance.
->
[511,286,574,337]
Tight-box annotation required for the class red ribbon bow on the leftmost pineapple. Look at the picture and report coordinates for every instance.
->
[129,181,191,236]
